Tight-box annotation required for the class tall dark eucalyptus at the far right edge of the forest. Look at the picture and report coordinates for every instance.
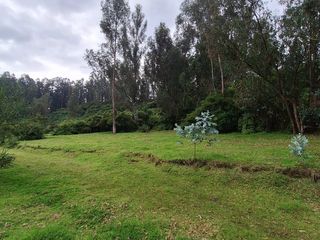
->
[280,0,320,133]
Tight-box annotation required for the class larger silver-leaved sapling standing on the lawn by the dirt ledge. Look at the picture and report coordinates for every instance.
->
[174,111,219,159]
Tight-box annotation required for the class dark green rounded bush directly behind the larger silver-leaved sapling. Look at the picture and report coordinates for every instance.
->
[183,94,239,133]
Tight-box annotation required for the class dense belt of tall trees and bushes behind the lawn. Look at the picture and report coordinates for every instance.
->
[0,0,320,141]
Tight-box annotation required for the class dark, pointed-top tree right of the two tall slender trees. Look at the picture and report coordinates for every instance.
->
[144,23,189,122]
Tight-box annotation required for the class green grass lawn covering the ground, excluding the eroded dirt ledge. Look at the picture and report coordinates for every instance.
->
[0,132,320,240]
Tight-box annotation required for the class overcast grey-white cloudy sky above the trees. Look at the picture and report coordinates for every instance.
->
[0,0,277,80]
